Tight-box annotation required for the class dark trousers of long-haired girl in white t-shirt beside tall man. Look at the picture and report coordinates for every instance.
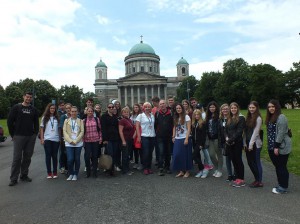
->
[44,140,59,173]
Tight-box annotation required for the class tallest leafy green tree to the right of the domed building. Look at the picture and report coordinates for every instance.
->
[214,58,250,108]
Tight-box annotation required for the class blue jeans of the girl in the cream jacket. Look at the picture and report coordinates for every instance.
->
[66,147,82,175]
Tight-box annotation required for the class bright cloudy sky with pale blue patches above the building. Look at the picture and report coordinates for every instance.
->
[0,0,300,92]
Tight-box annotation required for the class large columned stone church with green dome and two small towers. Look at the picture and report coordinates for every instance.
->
[94,40,189,106]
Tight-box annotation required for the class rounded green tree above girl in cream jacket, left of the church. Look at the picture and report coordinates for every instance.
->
[58,85,83,111]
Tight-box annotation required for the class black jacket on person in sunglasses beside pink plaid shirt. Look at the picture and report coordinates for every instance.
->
[101,112,120,141]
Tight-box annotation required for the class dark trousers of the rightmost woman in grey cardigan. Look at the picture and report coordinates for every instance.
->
[268,150,290,189]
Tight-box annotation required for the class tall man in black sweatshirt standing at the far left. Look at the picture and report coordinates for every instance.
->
[7,92,39,186]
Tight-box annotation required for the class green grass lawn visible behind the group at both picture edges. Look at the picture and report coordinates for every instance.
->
[0,110,300,176]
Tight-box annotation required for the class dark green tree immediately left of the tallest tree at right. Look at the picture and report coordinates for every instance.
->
[195,72,222,105]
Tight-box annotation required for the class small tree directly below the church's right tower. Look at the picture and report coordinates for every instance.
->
[176,75,199,102]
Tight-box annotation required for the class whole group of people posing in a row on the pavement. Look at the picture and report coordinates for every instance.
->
[7,92,291,194]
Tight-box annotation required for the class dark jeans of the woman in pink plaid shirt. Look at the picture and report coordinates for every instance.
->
[84,141,99,175]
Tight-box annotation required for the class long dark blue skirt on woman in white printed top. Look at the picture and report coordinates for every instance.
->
[172,138,193,171]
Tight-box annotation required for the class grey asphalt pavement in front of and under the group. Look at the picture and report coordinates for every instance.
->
[0,140,300,224]
